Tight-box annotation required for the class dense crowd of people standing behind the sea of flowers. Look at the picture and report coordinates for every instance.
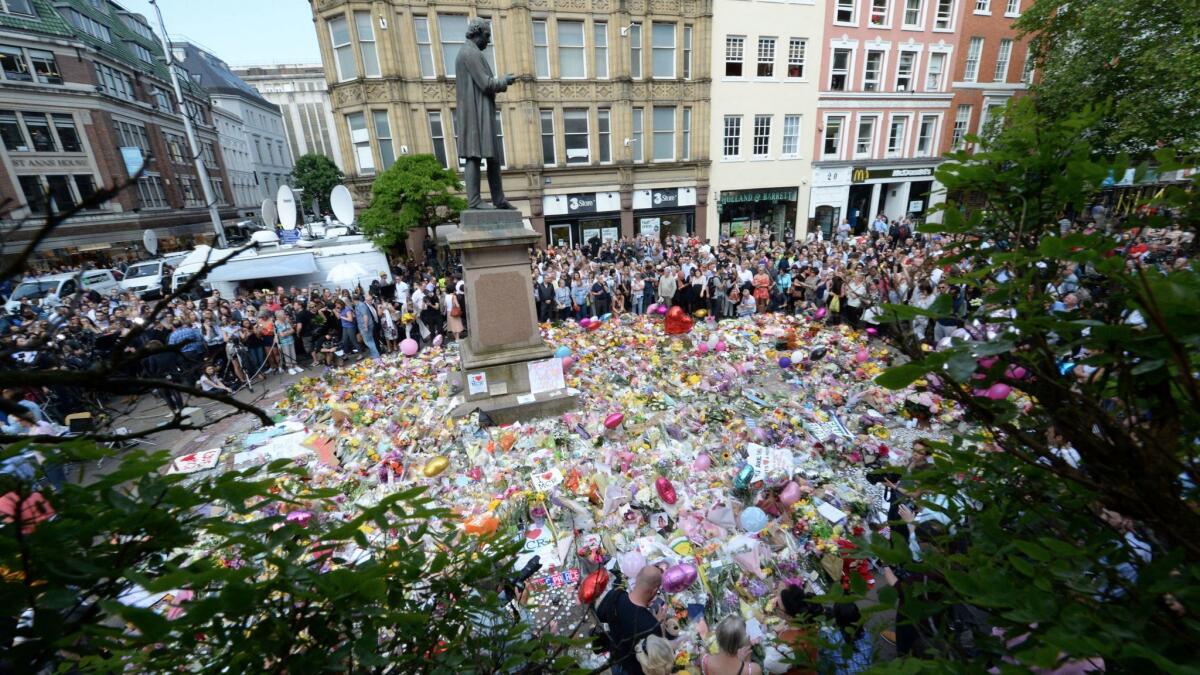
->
[0,208,1192,429]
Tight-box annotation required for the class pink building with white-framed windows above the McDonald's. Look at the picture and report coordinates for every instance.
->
[809,0,973,232]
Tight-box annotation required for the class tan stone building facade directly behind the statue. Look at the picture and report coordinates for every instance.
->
[312,0,712,245]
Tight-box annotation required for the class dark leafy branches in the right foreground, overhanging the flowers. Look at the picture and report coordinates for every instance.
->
[875,101,1200,673]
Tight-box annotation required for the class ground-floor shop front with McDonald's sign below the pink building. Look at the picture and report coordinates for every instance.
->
[809,163,941,238]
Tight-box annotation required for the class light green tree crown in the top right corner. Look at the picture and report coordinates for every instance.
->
[1018,0,1200,156]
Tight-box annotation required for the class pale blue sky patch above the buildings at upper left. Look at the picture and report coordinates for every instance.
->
[116,0,320,66]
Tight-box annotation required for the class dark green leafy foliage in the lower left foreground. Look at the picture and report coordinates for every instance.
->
[0,442,580,674]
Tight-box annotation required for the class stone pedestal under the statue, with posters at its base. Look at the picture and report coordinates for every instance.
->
[444,209,577,424]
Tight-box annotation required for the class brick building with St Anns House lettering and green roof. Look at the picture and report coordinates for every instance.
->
[0,0,234,268]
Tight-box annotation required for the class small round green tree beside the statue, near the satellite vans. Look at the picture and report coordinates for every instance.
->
[359,155,467,249]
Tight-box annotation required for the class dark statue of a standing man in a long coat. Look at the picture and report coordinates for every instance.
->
[454,18,516,209]
